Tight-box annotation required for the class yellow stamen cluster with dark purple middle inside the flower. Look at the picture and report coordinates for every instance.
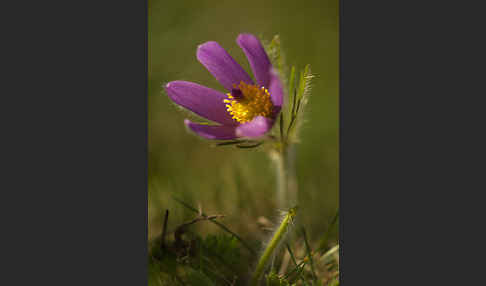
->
[224,81,273,123]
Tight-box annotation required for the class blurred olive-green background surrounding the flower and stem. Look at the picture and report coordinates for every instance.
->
[148,0,339,244]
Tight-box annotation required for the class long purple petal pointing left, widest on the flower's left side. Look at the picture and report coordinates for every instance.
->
[165,80,238,125]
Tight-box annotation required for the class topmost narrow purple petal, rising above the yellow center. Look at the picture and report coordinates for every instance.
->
[236,34,272,88]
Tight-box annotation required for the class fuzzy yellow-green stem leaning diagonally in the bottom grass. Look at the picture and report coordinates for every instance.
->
[250,207,297,286]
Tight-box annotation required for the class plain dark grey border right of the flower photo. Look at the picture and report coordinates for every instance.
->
[340,0,485,285]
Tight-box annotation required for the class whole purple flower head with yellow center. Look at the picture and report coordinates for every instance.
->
[165,34,283,140]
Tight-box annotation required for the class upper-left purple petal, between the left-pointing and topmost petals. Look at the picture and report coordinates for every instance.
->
[196,42,253,91]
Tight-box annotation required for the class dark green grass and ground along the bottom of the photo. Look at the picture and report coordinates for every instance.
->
[148,200,339,286]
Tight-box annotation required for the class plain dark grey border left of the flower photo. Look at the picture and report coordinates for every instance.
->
[4,1,148,285]
